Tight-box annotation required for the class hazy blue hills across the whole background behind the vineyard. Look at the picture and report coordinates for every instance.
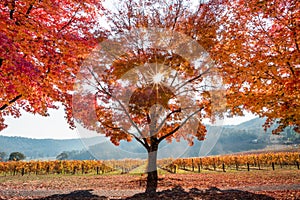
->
[0,118,300,160]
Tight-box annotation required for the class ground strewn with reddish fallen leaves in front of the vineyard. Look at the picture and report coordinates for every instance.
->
[0,170,300,200]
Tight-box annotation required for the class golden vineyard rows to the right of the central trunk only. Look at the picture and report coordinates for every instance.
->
[159,152,300,173]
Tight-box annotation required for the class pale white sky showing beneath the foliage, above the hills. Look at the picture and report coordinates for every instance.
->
[0,109,255,139]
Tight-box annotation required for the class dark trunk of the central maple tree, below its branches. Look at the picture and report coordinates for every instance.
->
[146,144,158,194]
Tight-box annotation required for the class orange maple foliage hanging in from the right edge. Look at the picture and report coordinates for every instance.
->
[210,0,300,134]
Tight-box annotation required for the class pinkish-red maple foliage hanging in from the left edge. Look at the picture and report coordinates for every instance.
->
[0,0,102,130]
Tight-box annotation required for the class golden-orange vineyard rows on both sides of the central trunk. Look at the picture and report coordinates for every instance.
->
[0,152,300,175]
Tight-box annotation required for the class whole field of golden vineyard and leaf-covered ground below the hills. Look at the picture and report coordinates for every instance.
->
[0,152,300,199]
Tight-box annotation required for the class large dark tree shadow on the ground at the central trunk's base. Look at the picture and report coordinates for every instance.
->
[126,186,274,200]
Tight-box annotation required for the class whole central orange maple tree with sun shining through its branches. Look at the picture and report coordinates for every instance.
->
[73,0,224,193]
